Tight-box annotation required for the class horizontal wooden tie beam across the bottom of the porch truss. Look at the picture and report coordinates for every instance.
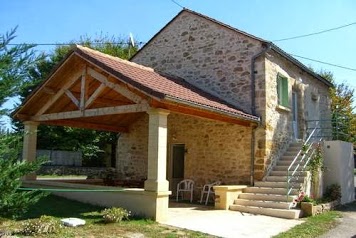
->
[31,103,149,121]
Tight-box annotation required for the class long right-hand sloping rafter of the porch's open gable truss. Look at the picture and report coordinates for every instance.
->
[87,68,145,103]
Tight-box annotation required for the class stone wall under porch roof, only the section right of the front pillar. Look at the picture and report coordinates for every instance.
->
[168,113,251,187]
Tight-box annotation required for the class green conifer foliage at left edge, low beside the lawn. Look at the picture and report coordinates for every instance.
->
[0,135,45,217]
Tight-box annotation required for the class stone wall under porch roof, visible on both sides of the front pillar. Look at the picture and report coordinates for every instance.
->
[117,113,251,193]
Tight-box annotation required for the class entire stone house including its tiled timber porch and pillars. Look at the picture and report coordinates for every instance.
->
[14,9,332,221]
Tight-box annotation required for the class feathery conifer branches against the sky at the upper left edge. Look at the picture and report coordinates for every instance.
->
[0,27,39,116]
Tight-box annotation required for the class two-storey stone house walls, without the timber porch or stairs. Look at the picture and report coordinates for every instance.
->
[127,9,331,190]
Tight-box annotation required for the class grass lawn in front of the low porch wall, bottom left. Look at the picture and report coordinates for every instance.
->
[0,196,213,238]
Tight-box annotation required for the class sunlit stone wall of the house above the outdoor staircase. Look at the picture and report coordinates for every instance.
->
[255,53,330,179]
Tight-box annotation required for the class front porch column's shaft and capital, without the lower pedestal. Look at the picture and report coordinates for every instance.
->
[145,109,169,192]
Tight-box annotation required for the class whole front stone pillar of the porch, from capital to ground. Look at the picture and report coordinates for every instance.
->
[145,109,171,222]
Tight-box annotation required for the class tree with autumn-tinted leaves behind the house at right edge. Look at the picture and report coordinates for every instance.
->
[320,71,356,143]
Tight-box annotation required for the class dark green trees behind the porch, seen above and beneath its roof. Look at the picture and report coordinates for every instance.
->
[13,35,138,166]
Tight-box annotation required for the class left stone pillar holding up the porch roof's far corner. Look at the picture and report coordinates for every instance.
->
[22,121,38,180]
